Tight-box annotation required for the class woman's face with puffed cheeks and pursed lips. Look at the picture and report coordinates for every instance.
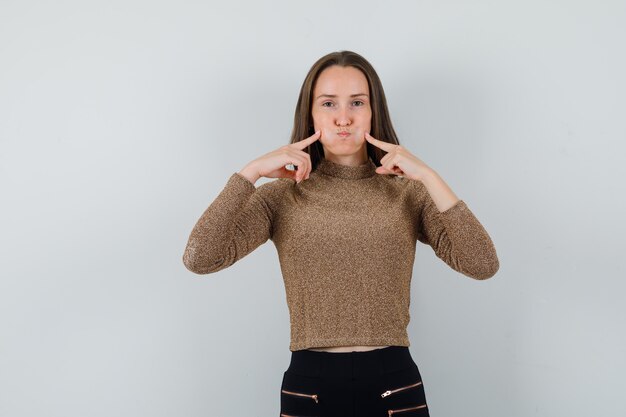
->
[311,65,372,156]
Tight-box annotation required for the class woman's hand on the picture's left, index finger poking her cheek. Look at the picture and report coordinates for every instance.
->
[239,131,321,184]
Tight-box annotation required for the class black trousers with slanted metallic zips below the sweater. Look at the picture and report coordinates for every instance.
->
[280,346,429,417]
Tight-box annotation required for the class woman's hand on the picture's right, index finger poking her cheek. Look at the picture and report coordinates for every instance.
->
[365,132,432,181]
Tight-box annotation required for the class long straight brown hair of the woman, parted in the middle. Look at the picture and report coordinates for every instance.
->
[290,51,399,169]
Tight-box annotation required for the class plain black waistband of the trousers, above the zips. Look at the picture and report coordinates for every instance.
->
[287,346,417,377]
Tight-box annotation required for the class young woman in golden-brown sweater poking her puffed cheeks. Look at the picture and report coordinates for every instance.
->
[183,51,499,417]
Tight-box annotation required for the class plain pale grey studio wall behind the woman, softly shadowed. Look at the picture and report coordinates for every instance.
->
[0,0,626,417]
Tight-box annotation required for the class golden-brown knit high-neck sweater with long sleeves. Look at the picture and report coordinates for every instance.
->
[183,159,499,351]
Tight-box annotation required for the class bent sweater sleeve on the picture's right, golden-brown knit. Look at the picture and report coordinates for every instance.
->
[414,181,500,280]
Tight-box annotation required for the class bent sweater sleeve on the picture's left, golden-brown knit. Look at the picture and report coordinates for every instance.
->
[183,173,272,274]
